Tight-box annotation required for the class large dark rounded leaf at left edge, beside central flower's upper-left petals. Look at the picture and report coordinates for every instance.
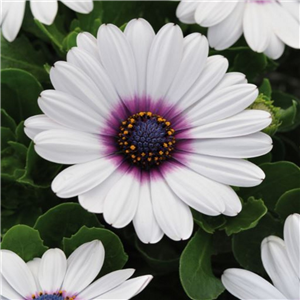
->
[0,69,42,123]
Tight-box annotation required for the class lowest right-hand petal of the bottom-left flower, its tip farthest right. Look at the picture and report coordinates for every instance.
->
[97,275,153,300]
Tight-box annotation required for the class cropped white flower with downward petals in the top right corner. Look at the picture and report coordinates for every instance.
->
[177,0,300,59]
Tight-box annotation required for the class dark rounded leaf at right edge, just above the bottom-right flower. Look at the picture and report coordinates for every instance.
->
[275,188,300,221]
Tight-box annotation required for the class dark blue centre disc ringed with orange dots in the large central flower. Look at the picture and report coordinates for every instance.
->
[118,112,176,170]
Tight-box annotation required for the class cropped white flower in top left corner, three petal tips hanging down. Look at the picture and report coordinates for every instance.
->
[0,0,93,42]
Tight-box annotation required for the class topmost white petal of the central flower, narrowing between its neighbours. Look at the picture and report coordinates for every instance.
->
[124,18,155,97]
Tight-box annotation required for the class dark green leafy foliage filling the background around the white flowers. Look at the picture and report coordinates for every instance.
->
[0,0,300,300]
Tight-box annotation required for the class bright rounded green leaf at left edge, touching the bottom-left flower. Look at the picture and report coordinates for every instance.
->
[0,225,48,261]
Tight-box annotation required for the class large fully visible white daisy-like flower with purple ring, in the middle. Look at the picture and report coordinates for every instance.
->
[25,19,272,243]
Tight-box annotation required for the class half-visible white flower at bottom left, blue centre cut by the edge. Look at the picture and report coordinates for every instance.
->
[0,240,152,300]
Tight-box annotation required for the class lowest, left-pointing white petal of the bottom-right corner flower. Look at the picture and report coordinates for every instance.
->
[221,269,288,300]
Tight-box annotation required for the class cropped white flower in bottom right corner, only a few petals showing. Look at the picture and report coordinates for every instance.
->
[222,214,300,300]
